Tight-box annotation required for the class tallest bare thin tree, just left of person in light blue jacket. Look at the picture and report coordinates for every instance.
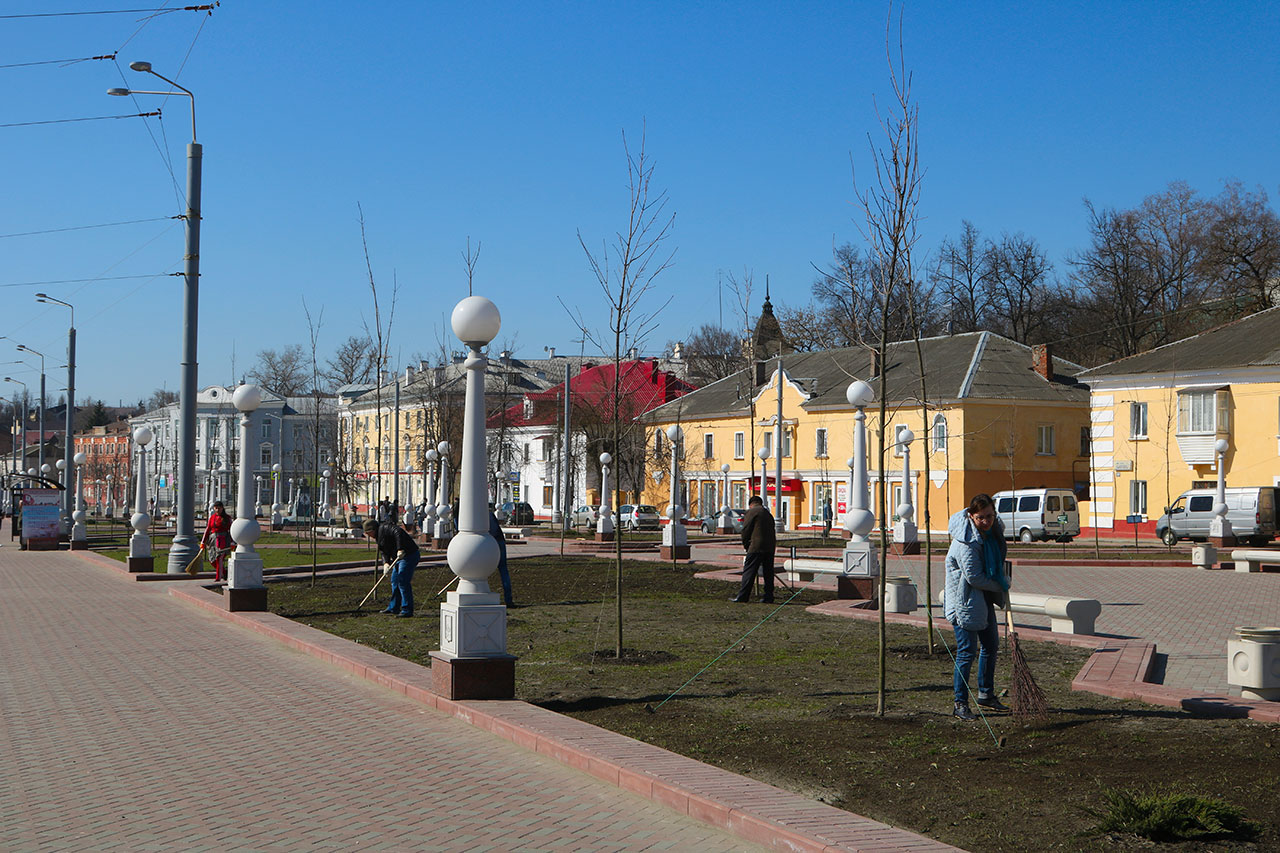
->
[855,10,920,716]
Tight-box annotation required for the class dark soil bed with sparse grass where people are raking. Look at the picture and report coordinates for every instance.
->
[270,557,1280,850]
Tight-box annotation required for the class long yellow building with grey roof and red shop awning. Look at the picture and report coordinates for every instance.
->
[643,332,1089,532]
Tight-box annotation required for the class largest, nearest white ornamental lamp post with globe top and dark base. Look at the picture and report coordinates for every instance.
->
[431,296,516,699]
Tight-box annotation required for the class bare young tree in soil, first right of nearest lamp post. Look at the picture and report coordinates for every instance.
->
[562,126,676,658]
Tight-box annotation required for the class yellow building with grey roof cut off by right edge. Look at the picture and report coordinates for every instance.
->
[1080,309,1280,533]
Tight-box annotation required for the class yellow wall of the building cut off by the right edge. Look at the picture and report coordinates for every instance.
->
[1091,371,1280,530]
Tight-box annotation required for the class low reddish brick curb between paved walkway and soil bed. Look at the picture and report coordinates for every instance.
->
[157,578,959,853]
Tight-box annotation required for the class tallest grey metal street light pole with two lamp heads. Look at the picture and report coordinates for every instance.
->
[106,60,204,575]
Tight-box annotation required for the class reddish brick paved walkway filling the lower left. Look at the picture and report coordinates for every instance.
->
[0,547,756,850]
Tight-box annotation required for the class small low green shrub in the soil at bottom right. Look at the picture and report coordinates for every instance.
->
[1094,789,1261,841]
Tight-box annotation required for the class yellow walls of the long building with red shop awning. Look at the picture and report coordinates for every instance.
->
[643,374,1088,532]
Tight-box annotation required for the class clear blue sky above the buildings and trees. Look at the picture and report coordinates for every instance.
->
[0,0,1280,403]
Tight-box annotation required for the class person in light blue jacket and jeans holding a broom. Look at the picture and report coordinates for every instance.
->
[942,494,1009,720]
